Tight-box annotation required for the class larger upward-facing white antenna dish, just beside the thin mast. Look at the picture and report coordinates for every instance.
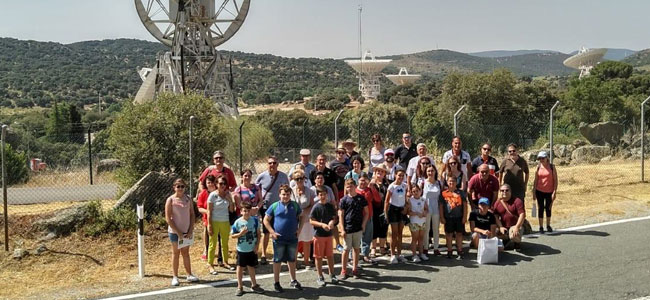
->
[345,51,392,99]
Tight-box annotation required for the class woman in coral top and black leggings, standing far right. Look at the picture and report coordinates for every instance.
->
[533,151,558,233]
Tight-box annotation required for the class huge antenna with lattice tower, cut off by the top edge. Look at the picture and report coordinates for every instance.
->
[134,0,250,115]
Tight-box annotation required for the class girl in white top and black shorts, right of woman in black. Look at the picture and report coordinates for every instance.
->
[384,169,408,264]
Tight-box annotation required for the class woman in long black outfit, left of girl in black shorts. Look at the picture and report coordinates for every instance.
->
[370,164,388,256]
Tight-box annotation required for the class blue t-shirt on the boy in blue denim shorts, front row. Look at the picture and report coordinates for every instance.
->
[266,201,302,242]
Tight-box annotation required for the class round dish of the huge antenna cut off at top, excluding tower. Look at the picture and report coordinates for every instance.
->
[135,0,250,47]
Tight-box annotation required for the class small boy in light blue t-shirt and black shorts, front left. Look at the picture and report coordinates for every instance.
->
[230,203,264,296]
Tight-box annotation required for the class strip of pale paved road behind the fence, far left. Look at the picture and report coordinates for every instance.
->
[7,184,117,205]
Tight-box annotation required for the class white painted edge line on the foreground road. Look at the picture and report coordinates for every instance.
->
[103,216,650,300]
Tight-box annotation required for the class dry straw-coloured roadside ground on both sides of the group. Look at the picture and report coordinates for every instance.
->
[0,161,650,299]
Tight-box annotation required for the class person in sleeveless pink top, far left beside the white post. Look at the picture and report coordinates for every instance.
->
[165,178,199,286]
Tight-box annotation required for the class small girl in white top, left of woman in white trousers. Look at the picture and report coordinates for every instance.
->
[408,184,429,263]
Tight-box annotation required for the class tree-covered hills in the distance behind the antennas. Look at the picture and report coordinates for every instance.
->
[0,38,571,107]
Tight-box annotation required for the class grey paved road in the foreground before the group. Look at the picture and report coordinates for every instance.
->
[104,219,650,300]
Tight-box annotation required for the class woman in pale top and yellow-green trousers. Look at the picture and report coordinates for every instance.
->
[208,175,235,275]
